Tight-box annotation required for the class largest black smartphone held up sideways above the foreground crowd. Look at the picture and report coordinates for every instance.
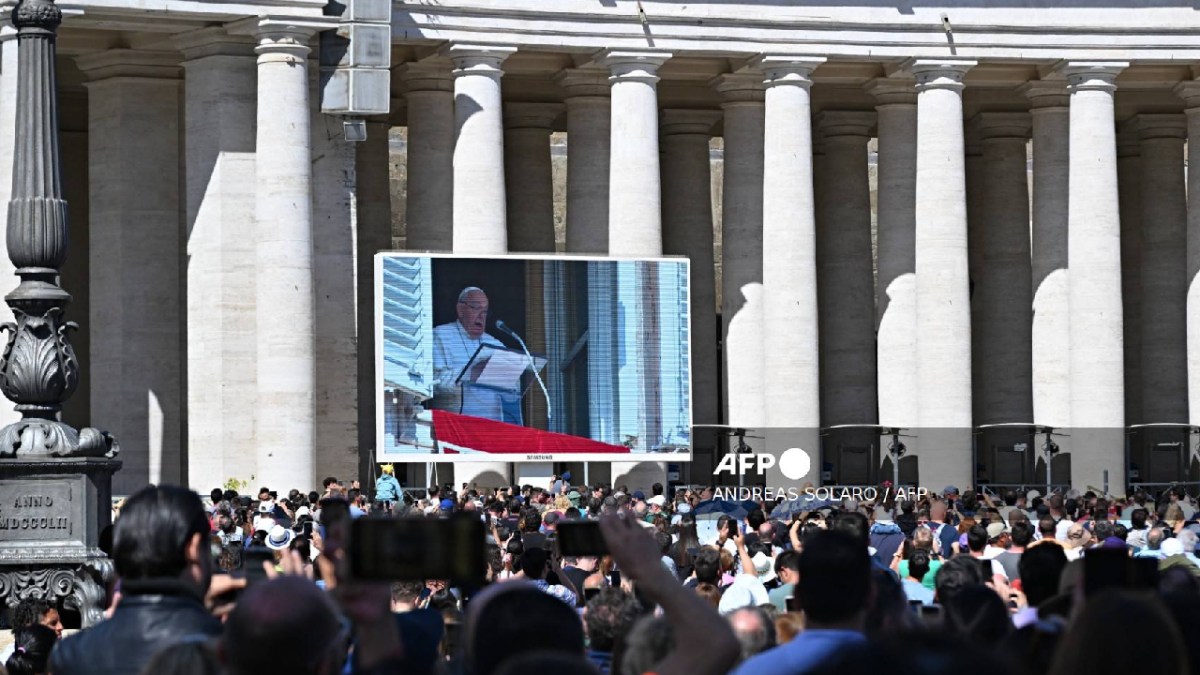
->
[348,514,487,584]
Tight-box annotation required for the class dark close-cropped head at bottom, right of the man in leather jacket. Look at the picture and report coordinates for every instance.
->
[221,577,344,675]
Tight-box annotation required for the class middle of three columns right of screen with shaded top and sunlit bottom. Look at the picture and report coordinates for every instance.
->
[868,78,919,428]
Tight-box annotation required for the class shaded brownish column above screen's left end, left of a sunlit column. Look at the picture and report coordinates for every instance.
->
[405,59,455,251]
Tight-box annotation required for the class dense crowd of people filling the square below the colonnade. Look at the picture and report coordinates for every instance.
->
[2,467,1200,675]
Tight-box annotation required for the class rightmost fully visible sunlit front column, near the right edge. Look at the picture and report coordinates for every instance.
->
[1063,62,1128,486]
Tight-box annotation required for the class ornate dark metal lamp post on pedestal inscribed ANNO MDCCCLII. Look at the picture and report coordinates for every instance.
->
[0,0,121,627]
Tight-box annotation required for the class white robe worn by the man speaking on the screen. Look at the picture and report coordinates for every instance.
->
[433,321,521,424]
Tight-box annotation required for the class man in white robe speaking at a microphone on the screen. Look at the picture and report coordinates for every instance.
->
[433,286,522,424]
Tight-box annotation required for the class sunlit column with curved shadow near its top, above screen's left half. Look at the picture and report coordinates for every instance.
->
[445,44,516,255]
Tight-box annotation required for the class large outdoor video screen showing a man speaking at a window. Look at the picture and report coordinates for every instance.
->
[376,253,691,461]
